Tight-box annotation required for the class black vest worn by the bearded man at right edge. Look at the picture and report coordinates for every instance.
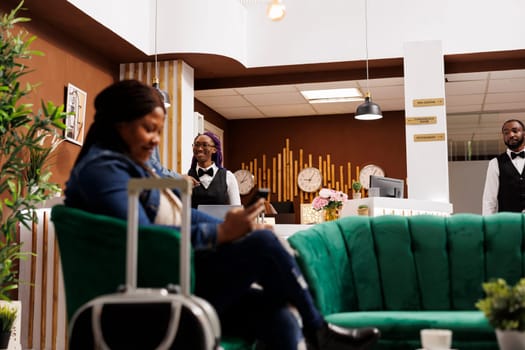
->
[498,153,525,212]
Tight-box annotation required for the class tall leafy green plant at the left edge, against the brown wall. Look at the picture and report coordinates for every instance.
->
[0,1,66,300]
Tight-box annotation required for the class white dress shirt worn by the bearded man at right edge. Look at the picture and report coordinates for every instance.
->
[482,149,525,215]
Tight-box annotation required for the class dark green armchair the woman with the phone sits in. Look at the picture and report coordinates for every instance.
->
[51,205,252,350]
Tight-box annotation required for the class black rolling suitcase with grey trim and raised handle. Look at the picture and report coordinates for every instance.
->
[69,178,221,350]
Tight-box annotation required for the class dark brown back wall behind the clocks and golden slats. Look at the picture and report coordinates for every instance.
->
[226,111,406,212]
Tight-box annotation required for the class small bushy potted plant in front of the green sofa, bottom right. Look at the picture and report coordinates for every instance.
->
[476,278,525,350]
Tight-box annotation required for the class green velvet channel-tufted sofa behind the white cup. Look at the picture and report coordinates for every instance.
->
[288,213,525,350]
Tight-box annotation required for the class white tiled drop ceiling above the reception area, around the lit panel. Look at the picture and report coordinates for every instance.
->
[195,70,525,155]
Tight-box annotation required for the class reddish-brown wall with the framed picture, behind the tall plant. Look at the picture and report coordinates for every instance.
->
[0,9,119,188]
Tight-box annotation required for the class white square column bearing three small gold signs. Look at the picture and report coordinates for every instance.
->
[404,41,449,202]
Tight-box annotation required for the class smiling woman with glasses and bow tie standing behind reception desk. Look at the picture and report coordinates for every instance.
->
[188,131,241,208]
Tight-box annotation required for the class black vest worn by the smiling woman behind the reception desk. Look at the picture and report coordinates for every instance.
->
[188,168,230,208]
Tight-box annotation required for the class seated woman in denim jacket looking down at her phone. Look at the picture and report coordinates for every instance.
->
[65,80,379,350]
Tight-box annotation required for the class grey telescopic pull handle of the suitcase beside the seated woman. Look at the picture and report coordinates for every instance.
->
[126,178,192,296]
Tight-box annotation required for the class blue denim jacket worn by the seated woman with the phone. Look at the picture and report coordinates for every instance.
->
[65,145,222,249]
